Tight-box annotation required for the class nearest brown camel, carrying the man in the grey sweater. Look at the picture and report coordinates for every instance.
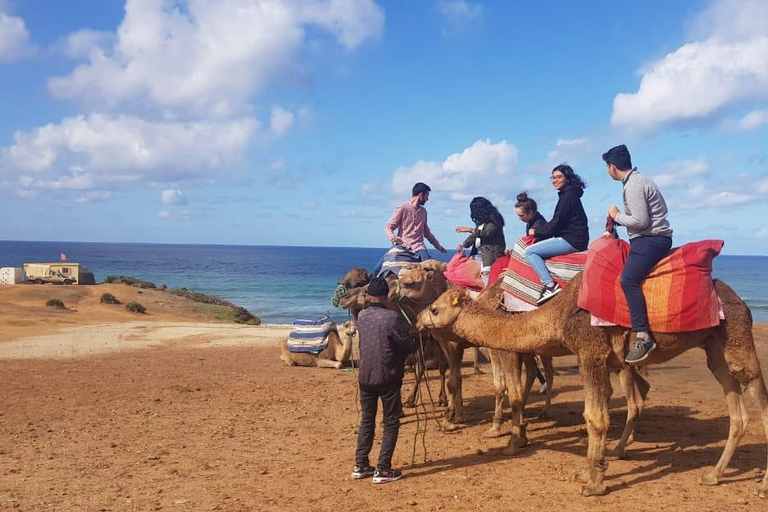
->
[418,274,768,498]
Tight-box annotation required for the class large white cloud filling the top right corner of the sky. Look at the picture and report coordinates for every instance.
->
[611,0,768,130]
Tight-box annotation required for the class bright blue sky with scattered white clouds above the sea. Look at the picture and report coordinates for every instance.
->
[0,0,768,254]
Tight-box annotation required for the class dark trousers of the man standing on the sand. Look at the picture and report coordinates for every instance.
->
[355,386,403,471]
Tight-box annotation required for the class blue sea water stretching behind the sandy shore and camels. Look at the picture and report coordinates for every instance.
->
[0,241,768,324]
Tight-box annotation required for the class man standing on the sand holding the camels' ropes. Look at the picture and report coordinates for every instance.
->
[352,277,416,484]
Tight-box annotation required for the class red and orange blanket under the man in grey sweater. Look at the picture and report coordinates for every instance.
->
[578,238,723,332]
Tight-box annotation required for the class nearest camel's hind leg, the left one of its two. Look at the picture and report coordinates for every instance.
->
[701,343,749,485]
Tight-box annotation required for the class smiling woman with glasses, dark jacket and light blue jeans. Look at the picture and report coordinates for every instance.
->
[525,164,589,304]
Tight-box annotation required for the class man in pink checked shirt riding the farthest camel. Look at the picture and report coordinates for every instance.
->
[384,182,448,261]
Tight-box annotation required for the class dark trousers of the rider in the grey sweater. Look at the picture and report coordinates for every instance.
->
[621,236,672,332]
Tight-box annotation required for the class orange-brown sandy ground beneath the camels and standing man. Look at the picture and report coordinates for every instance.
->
[0,286,768,511]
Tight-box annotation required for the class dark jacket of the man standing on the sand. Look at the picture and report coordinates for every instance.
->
[357,304,416,389]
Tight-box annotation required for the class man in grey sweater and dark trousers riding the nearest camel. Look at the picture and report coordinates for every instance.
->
[603,144,672,364]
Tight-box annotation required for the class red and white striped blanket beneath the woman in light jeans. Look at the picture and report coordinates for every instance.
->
[498,236,587,310]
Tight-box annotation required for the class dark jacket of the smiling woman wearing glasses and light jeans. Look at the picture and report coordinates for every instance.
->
[534,187,589,251]
